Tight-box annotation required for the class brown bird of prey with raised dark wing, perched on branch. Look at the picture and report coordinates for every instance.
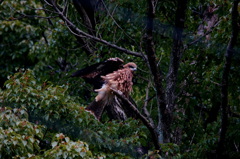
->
[72,57,137,120]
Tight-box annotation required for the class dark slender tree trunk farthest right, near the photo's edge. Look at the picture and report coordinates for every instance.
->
[217,0,239,158]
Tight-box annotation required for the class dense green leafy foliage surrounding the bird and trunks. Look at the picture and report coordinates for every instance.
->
[0,0,240,159]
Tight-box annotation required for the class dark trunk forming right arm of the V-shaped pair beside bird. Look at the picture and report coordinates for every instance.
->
[163,0,188,142]
